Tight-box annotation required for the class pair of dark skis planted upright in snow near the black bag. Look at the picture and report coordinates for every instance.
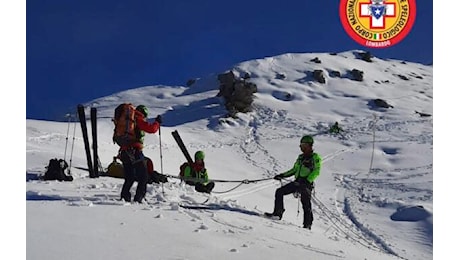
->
[77,104,100,178]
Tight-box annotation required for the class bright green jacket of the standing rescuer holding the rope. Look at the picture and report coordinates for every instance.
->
[282,153,321,183]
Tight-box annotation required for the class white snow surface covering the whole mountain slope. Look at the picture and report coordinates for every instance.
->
[26,50,433,260]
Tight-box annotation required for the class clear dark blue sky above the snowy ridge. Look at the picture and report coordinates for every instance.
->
[26,0,433,120]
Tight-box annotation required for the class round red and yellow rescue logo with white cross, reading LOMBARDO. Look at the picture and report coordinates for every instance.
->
[339,0,416,48]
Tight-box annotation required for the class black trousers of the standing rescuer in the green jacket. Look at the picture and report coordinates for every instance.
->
[273,179,313,226]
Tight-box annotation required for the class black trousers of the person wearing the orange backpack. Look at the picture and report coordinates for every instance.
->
[120,149,148,203]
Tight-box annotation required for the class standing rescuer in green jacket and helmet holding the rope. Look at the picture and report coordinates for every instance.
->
[265,135,321,229]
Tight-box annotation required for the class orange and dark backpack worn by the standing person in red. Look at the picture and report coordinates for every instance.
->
[112,103,136,146]
